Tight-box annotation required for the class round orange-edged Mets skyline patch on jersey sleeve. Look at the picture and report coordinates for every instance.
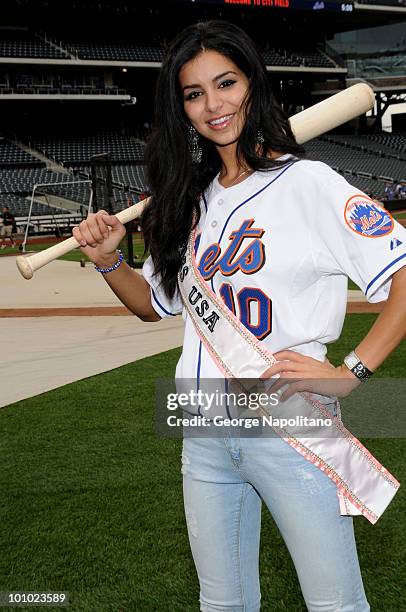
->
[344,195,393,238]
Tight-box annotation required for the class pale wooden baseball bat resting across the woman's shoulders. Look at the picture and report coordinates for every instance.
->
[16,83,375,279]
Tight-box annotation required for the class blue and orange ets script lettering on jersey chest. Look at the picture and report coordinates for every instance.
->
[198,219,265,280]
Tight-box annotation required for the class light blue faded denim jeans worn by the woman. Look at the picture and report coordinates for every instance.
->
[182,432,370,612]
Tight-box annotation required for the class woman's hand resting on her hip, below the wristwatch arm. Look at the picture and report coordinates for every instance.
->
[260,350,361,402]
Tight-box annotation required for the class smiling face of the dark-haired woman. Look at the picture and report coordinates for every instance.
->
[179,50,249,146]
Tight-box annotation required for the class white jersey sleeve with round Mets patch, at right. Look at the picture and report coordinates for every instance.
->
[312,163,406,302]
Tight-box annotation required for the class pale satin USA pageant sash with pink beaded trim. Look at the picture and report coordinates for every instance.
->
[178,227,399,523]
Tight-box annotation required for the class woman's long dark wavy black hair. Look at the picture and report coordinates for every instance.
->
[141,21,304,298]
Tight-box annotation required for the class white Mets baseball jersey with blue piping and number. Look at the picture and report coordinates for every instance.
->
[143,156,406,381]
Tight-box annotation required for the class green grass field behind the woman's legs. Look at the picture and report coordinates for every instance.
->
[0,315,406,612]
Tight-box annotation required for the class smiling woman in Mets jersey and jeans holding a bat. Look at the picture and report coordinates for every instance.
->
[74,22,406,612]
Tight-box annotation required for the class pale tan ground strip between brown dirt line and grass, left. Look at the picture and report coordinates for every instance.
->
[0,316,183,406]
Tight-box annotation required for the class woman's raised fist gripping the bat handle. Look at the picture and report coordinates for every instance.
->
[72,210,126,268]
